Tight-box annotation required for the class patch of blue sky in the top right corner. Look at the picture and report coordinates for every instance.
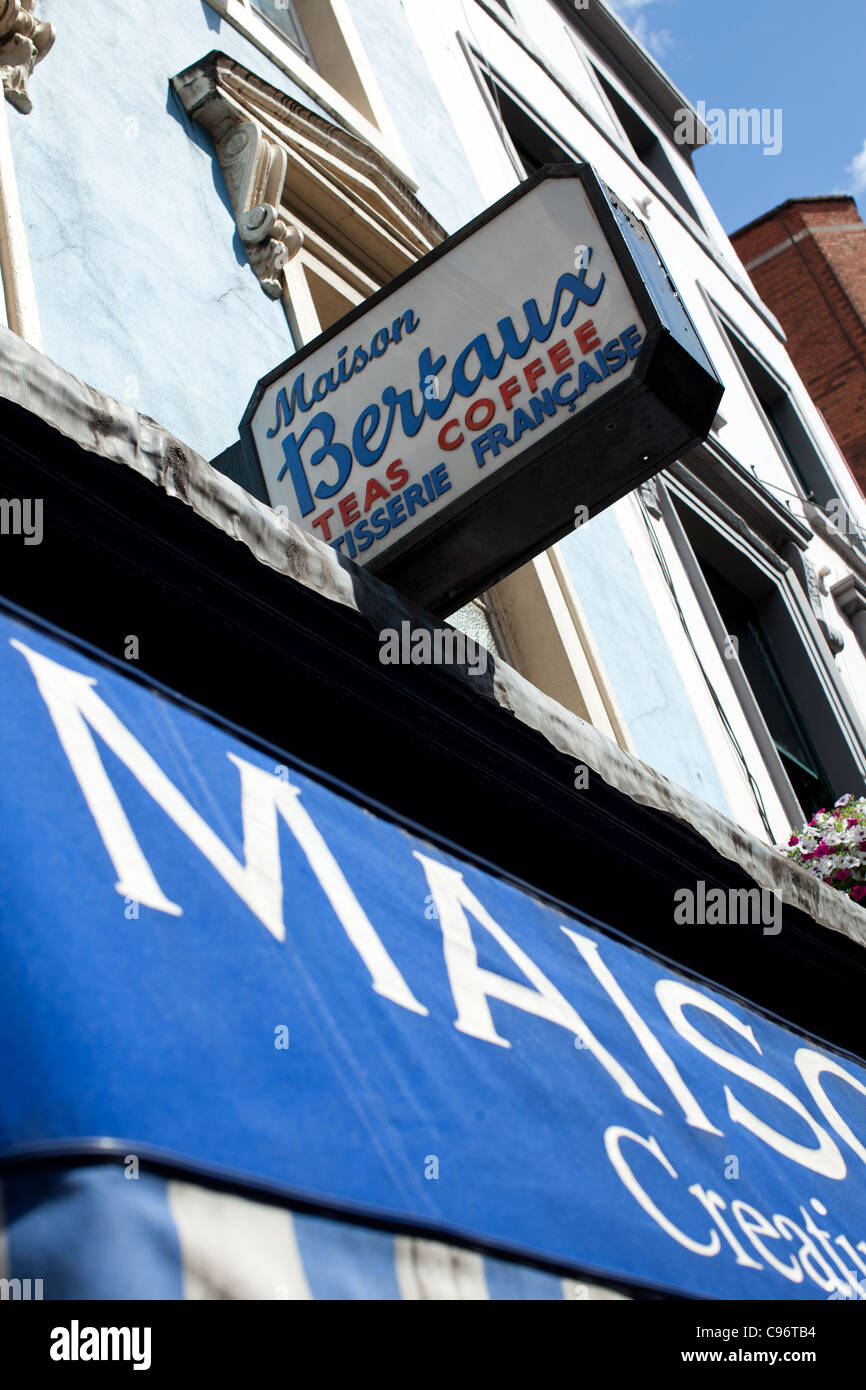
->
[607,0,866,232]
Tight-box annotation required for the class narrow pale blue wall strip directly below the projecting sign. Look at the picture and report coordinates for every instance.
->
[557,510,731,816]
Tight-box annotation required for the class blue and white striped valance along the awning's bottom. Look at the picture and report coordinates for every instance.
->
[0,1163,627,1301]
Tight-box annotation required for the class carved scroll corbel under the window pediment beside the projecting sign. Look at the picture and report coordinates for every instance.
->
[170,61,303,299]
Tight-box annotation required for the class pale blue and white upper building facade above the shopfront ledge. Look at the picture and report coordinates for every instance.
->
[6,0,866,840]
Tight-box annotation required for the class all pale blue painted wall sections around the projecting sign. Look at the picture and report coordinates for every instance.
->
[8,0,728,812]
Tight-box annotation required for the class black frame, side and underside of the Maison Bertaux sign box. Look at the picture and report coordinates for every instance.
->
[240,161,723,616]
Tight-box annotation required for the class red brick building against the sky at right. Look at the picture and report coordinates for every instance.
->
[731,195,866,492]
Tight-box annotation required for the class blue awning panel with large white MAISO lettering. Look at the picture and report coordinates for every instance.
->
[0,600,866,1298]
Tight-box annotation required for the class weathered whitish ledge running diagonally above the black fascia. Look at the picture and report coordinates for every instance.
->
[0,328,866,947]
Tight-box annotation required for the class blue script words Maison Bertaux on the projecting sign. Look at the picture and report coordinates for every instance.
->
[267,247,608,516]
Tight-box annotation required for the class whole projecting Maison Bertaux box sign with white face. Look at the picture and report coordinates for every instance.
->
[240,164,721,612]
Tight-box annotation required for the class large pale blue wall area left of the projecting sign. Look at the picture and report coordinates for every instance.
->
[7,0,328,457]
